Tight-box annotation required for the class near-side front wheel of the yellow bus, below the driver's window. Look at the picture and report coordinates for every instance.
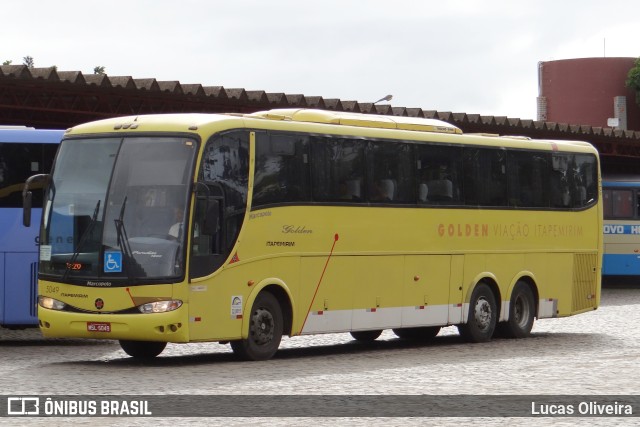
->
[231,292,284,360]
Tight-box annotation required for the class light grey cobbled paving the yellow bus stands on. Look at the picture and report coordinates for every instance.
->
[0,282,640,425]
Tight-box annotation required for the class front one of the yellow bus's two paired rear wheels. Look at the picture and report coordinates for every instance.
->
[458,283,498,342]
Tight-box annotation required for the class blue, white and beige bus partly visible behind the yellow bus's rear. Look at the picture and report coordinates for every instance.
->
[602,176,640,280]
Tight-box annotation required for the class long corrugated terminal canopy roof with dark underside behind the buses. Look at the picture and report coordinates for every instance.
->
[0,65,640,173]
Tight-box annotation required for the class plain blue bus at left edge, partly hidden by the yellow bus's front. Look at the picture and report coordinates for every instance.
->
[0,126,64,329]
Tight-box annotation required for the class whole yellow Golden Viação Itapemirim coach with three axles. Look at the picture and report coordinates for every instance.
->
[24,109,602,360]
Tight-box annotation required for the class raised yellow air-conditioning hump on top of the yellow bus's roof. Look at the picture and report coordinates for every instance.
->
[245,108,462,134]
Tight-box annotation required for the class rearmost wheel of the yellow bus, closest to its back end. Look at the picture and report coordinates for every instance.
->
[496,281,536,338]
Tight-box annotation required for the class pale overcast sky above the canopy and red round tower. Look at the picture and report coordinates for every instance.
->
[0,0,640,118]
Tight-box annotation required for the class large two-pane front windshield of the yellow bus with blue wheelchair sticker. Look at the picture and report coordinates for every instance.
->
[40,137,197,284]
